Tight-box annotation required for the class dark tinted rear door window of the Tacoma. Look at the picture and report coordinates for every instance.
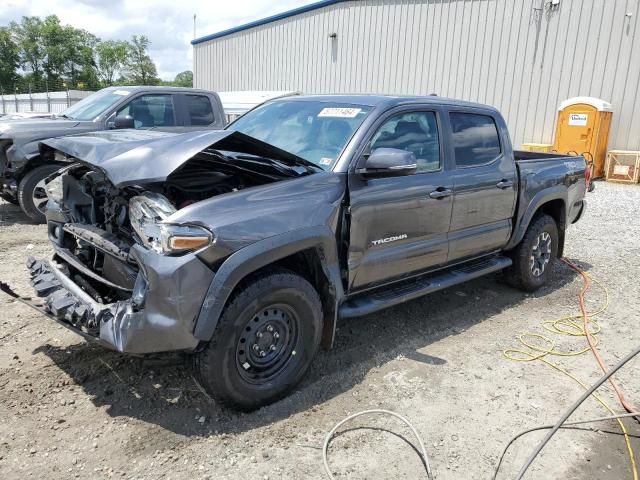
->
[449,112,500,167]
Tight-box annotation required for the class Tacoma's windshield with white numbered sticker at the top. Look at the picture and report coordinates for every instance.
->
[227,100,371,170]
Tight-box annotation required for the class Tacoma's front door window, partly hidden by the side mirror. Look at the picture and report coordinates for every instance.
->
[371,112,440,173]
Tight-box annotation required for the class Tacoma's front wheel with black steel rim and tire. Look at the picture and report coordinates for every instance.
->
[189,270,323,410]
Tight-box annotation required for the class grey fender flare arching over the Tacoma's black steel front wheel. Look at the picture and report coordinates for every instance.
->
[194,227,344,349]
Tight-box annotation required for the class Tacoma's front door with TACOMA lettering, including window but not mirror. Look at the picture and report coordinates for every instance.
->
[348,106,453,291]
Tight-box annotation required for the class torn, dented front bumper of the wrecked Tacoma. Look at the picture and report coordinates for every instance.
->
[27,247,213,354]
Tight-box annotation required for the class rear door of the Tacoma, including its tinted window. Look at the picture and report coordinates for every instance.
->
[446,109,517,262]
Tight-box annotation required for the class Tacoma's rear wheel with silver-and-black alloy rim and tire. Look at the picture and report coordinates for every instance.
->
[505,215,558,292]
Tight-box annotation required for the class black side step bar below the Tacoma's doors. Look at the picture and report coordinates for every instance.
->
[338,256,512,318]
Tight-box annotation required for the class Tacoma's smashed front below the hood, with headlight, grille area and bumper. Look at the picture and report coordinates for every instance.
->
[27,164,231,353]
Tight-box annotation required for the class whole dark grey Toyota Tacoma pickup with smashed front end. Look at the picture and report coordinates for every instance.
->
[28,96,589,409]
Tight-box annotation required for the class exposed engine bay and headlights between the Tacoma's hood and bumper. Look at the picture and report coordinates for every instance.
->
[46,150,300,318]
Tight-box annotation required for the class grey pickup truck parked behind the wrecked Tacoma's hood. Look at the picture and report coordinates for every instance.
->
[0,86,225,223]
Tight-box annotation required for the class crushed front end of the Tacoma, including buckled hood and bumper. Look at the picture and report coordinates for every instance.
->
[28,130,317,353]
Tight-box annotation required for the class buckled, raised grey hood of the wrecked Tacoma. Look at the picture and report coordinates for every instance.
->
[41,130,319,186]
